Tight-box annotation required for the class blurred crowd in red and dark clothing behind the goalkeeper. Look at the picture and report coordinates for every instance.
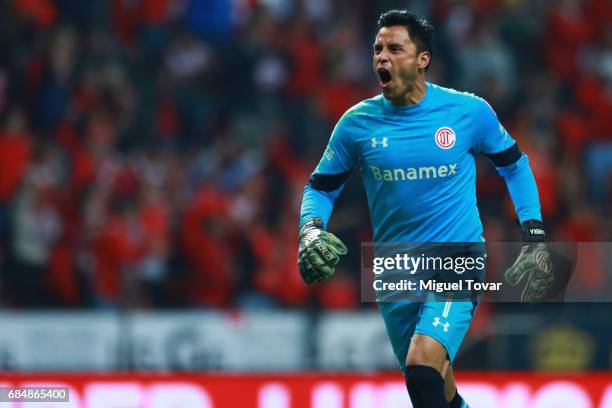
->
[0,0,612,309]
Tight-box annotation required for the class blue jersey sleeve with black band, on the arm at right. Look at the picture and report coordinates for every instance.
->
[474,99,542,223]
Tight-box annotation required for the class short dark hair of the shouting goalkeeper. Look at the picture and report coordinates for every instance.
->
[378,10,434,56]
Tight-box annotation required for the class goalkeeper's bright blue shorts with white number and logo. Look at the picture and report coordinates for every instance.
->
[378,299,478,373]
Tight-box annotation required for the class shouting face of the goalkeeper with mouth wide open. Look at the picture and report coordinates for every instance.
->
[373,26,430,105]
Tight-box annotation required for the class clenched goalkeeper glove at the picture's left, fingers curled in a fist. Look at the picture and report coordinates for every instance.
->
[298,218,348,285]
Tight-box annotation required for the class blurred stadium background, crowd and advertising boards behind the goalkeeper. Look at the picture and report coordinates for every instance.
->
[0,0,612,407]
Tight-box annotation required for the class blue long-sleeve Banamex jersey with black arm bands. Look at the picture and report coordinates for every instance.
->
[300,83,542,242]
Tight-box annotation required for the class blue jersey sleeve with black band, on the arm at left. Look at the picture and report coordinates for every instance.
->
[299,114,356,228]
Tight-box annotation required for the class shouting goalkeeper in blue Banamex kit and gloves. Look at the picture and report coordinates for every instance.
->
[298,10,551,408]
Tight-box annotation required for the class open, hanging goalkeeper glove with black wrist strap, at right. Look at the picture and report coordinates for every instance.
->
[505,220,555,303]
